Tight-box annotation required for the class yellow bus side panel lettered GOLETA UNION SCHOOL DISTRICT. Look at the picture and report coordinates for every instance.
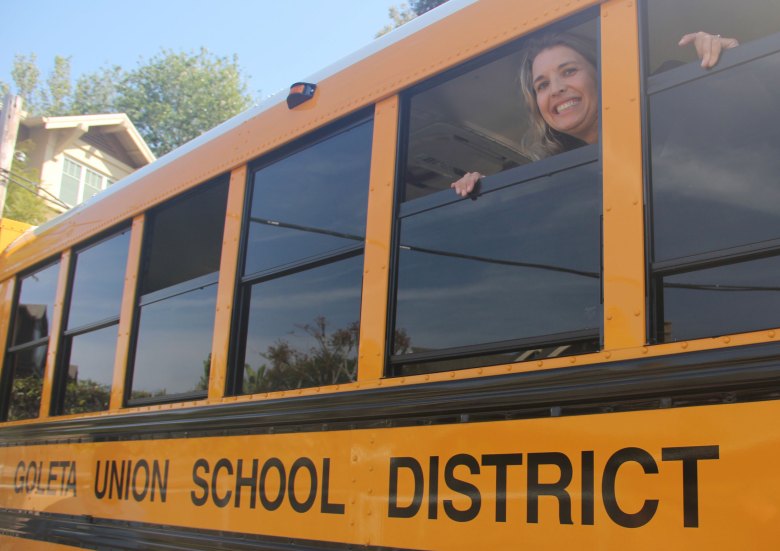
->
[0,401,780,549]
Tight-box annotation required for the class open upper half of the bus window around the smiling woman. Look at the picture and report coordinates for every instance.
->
[403,17,598,201]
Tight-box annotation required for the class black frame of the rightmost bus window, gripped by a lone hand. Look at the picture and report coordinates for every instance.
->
[639,0,780,344]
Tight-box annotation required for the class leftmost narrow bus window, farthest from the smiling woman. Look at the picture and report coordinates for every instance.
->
[2,261,60,421]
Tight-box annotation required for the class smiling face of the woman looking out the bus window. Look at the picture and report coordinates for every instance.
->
[531,45,599,143]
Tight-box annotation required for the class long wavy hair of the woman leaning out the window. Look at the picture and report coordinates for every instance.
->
[519,33,597,161]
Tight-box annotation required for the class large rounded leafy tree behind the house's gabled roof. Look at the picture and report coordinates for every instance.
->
[116,48,251,155]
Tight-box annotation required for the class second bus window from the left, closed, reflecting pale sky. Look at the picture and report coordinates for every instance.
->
[53,229,130,414]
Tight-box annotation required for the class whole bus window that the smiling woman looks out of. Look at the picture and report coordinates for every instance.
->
[390,14,601,375]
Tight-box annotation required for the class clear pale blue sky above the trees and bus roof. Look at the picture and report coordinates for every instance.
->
[0,0,401,99]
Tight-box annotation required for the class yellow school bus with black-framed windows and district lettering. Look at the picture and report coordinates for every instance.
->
[0,0,780,550]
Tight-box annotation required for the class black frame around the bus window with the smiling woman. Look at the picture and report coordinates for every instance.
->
[384,6,604,377]
